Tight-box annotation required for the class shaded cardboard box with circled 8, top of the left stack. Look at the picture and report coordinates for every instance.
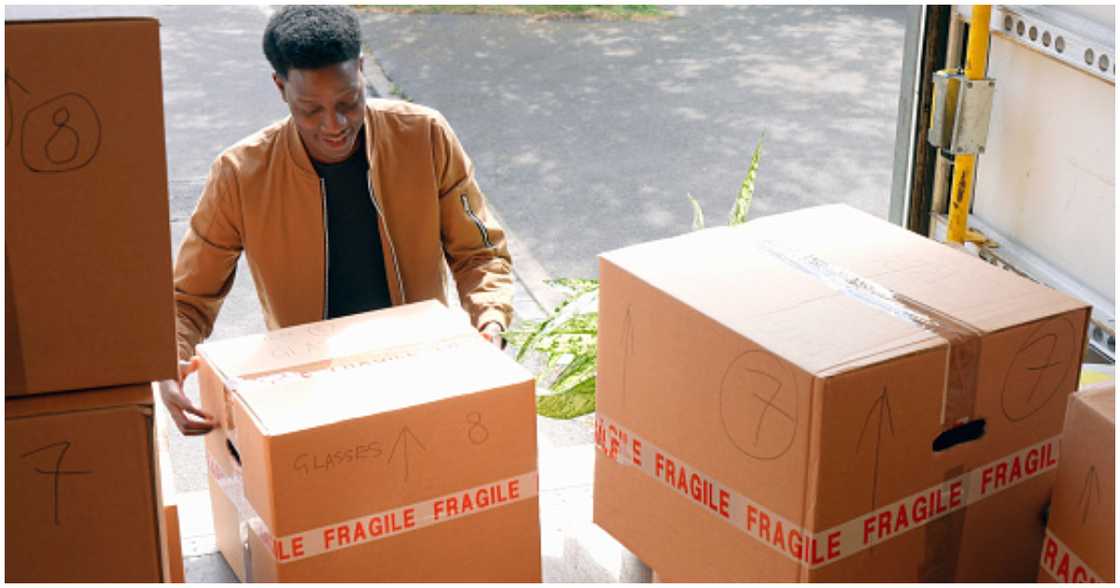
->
[4,19,176,396]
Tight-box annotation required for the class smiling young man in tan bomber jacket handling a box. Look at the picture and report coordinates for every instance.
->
[160,6,513,435]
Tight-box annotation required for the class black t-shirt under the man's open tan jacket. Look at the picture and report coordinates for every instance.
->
[311,129,392,318]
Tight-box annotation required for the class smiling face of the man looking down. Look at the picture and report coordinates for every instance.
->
[272,58,365,164]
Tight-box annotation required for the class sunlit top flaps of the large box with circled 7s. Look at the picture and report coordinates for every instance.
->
[603,205,1085,375]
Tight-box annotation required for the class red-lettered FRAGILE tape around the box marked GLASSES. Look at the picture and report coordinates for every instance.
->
[207,455,539,563]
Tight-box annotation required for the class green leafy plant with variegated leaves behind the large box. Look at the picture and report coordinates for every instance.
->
[504,133,765,419]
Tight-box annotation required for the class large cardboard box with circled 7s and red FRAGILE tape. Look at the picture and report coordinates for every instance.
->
[594,206,1089,581]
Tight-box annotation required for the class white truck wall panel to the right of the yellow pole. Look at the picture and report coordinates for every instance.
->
[962,6,1116,306]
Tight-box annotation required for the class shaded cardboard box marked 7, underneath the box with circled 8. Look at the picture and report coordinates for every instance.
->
[4,384,161,582]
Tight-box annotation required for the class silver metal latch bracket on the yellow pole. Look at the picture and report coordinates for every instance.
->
[926,69,996,155]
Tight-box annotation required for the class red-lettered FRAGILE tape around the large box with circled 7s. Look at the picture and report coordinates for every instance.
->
[595,416,1058,569]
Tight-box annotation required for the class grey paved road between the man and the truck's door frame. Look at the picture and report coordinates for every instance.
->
[363,6,906,277]
